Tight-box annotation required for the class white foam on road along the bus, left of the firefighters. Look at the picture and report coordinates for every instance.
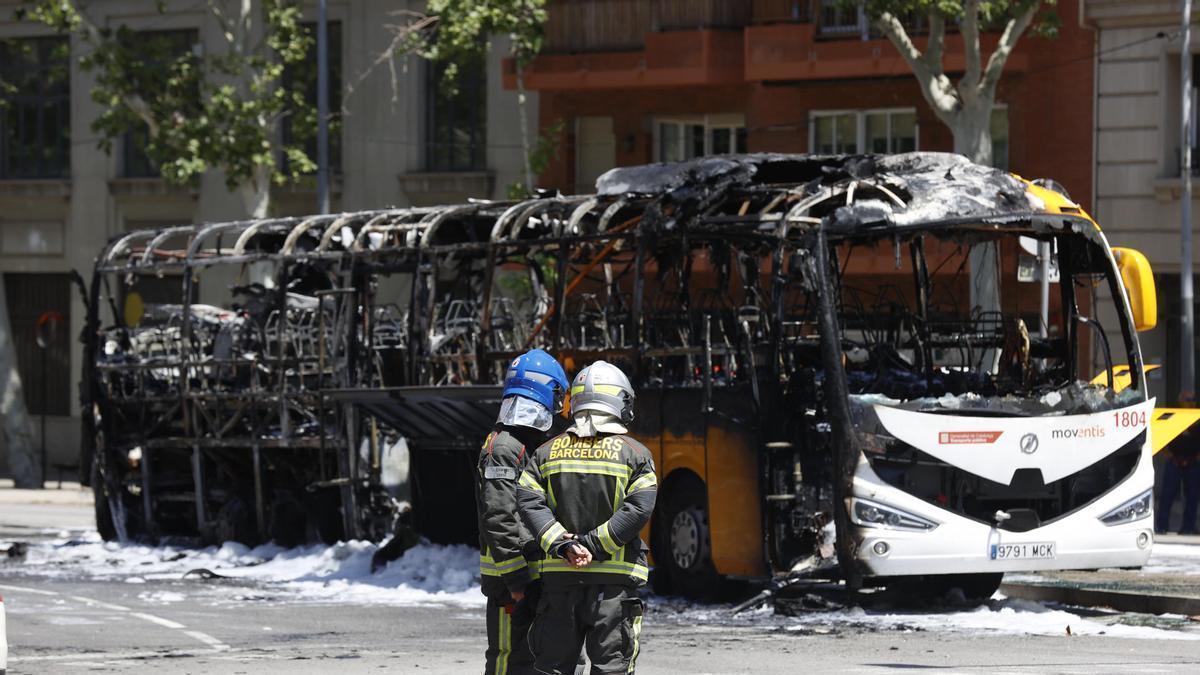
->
[17,532,486,607]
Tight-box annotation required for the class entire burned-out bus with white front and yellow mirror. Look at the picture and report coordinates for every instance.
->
[83,153,1156,596]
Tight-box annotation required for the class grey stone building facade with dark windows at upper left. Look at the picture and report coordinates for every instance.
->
[0,0,538,478]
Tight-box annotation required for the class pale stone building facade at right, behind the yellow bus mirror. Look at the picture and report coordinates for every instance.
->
[1082,0,1200,401]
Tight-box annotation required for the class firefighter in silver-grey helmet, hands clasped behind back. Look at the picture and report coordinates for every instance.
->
[517,362,658,675]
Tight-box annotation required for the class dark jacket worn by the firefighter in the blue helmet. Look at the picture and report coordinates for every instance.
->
[475,425,545,599]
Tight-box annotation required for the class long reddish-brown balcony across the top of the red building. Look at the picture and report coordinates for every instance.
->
[504,0,1028,91]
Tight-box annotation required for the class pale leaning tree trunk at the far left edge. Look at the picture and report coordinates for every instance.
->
[0,274,42,488]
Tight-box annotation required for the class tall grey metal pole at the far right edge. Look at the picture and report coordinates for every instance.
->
[1180,0,1195,401]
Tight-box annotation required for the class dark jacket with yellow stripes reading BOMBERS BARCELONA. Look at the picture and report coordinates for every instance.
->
[517,432,658,586]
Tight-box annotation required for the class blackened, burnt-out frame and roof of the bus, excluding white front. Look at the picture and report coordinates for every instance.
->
[80,153,1121,586]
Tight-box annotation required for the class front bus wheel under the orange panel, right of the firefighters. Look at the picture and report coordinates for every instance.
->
[654,479,719,599]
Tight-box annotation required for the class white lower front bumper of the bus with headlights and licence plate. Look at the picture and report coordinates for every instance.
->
[847,455,1154,577]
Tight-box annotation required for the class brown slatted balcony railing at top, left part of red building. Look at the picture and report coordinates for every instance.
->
[542,0,752,54]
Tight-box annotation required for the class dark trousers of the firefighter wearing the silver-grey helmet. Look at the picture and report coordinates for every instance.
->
[529,584,642,675]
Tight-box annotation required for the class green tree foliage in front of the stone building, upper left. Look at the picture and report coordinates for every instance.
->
[19,0,316,216]
